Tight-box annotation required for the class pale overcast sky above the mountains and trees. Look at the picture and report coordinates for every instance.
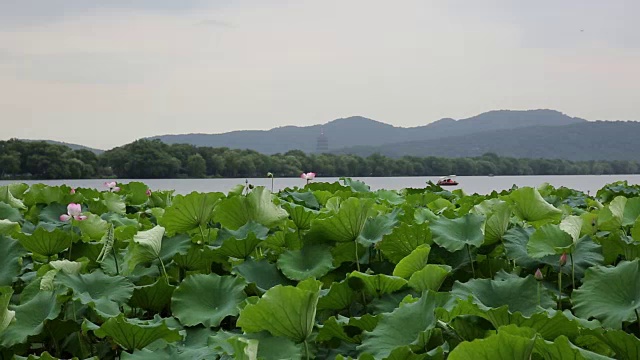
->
[0,0,640,149]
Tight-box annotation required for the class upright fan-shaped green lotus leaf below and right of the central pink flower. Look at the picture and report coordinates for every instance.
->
[307,198,374,242]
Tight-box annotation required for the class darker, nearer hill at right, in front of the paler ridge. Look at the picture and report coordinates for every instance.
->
[335,121,640,161]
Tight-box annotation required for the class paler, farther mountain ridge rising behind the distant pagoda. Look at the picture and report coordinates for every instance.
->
[151,110,586,154]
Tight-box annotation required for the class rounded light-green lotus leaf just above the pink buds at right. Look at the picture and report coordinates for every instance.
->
[527,224,574,259]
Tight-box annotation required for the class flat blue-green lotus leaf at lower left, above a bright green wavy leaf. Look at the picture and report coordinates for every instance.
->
[56,271,134,317]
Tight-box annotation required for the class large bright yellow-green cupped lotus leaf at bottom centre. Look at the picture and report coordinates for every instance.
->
[237,279,322,342]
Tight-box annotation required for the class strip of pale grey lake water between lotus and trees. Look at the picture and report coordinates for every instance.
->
[0,175,640,194]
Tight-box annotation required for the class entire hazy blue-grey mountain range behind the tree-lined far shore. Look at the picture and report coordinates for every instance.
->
[25,109,640,161]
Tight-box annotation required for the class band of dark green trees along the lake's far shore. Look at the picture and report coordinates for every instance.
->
[0,139,640,180]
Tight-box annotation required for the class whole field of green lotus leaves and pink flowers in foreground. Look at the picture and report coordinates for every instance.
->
[0,177,640,360]
